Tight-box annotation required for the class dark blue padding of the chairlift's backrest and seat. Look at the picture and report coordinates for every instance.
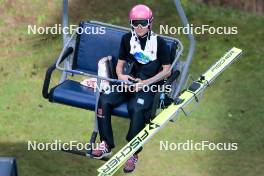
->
[49,22,177,117]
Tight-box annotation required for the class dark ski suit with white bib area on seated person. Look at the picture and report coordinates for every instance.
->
[97,32,170,152]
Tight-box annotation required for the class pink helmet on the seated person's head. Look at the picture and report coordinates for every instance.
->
[129,4,153,22]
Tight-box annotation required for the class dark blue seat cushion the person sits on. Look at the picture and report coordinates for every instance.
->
[49,80,129,117]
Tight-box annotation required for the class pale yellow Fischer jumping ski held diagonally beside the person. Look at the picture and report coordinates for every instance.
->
[97,47,242,176]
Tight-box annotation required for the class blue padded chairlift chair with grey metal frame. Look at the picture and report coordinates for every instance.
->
[42,0,195,156]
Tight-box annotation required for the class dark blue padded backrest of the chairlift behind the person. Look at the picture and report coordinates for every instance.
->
[73,22,178,74]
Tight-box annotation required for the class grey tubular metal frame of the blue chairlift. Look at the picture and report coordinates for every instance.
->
[45,0,195,156]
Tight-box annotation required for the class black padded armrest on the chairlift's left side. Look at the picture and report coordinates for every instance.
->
[42,47,73,99]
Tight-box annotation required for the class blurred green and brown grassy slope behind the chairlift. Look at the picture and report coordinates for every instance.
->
[0,0,264,176]
